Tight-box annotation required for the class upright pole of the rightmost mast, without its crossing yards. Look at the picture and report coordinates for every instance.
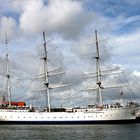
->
[95,30,103,107]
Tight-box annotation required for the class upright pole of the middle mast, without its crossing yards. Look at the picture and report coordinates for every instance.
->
[42,32,51,112]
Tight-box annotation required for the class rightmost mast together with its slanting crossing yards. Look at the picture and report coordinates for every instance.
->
[82,30,129,106]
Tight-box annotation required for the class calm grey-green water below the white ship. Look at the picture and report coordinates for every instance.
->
[0,124,140,140]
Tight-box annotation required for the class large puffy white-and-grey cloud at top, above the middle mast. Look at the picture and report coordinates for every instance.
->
[10,0,94,38]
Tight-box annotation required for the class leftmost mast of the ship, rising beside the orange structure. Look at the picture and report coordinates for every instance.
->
[5,35,11,106]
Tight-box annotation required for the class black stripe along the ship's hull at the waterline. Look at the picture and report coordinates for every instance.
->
[0,120,140,125]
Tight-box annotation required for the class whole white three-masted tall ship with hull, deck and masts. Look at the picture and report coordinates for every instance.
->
[0,31,137,124]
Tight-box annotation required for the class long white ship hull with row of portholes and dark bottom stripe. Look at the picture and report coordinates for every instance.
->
[0,108,135,124]
